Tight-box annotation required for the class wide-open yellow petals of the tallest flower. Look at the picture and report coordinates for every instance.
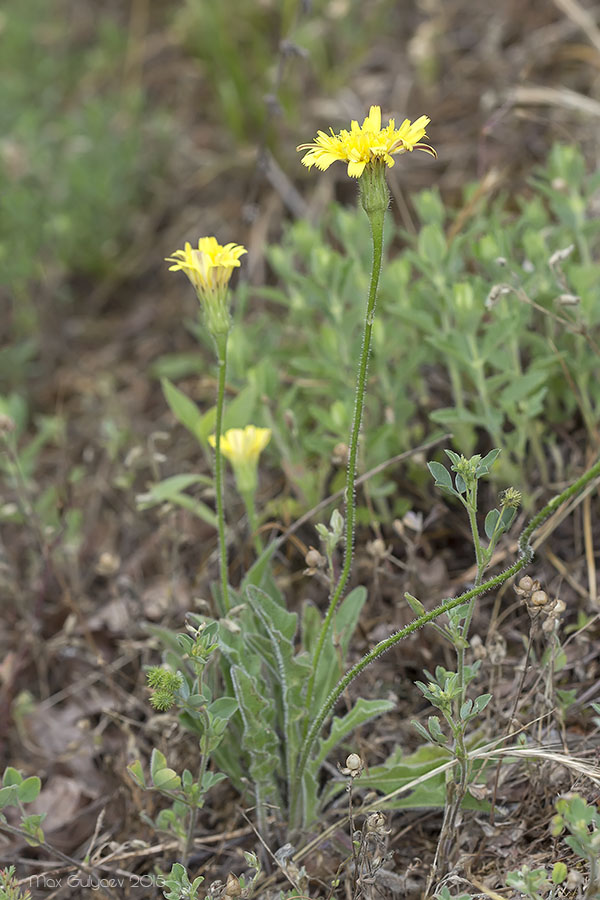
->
[296,106,437,178]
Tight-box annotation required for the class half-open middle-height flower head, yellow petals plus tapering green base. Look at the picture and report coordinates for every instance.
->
[166,237,247,336]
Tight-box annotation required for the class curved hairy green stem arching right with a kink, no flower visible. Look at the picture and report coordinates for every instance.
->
[291,459,600,821]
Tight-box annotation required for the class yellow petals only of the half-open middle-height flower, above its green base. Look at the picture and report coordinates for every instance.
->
[166,237,248,298]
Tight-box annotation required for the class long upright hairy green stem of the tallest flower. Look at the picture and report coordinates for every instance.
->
[304,204,387,726]
